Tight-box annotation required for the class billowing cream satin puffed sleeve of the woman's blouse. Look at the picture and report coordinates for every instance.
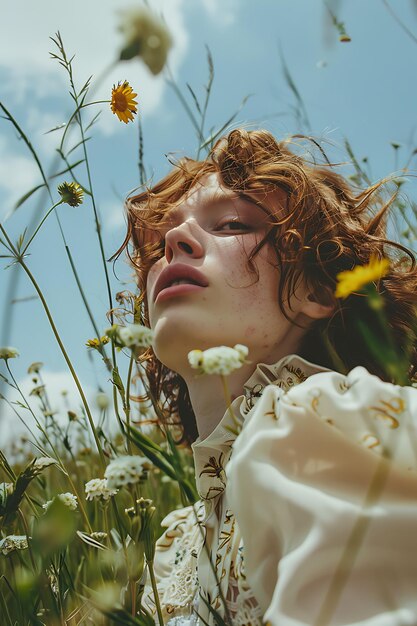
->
[226,367,417,626]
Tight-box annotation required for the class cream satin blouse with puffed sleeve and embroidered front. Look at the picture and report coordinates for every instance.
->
[144,355,417,626]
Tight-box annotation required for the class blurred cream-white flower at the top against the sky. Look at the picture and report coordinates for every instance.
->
[119,7,172,74]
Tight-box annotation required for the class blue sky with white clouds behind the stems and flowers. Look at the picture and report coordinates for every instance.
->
[0,0,417,434]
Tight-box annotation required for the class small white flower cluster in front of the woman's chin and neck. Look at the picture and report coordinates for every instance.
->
[188,343,249,376]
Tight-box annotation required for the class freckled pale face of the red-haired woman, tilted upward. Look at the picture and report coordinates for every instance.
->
[147,174,310,376]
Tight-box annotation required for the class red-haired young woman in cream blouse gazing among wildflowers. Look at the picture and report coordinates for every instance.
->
[118,129,417,626]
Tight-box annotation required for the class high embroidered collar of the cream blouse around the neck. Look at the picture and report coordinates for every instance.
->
[191,354,328,508]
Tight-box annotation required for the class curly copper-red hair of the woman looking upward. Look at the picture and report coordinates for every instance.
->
[116,129,417,442]
